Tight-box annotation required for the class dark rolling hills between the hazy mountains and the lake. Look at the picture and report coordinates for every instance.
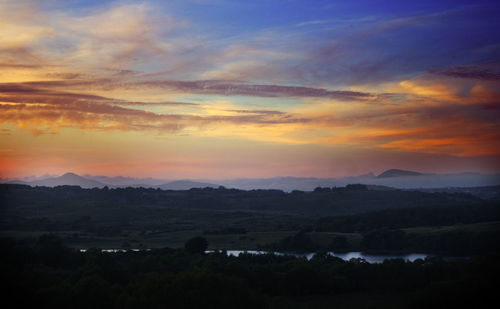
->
[0,185,500,256]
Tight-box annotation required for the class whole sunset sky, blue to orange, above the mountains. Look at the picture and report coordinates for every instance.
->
[0,0,500,179]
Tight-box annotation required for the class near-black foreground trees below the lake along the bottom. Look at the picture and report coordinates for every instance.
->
[0,235,500,309]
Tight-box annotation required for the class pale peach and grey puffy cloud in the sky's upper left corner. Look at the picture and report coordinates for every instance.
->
[0,1,187,74]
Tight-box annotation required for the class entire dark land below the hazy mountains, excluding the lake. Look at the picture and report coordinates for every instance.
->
[0,185,500,308]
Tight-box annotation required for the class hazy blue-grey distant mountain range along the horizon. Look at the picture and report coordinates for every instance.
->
[1,169,500,192]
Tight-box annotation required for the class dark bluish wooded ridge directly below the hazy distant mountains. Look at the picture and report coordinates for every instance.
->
[0,184,482,217]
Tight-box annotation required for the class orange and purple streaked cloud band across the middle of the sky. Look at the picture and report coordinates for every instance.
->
[0,71,500,155]
